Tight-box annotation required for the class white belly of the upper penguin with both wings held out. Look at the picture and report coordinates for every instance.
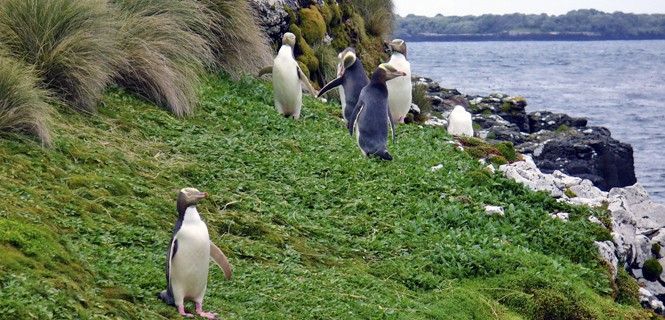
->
[272,56,302,115]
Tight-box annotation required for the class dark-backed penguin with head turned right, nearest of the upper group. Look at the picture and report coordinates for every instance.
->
[348,63,406,160]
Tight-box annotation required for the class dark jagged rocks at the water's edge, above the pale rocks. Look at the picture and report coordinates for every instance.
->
[413,77,637,191]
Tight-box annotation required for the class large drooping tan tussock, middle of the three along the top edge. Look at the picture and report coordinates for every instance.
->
[114,0,214,116]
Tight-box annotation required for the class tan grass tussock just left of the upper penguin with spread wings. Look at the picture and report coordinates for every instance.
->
[203,0,272,77]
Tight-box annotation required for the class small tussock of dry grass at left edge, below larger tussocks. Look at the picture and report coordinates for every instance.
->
[0,55,51,145]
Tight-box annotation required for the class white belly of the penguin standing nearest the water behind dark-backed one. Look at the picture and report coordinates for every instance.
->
[386,57,412,122]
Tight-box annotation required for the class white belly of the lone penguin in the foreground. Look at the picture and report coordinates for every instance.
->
[171,221,210,299]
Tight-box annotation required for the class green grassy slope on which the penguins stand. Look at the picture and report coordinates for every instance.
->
[0,74,645,319]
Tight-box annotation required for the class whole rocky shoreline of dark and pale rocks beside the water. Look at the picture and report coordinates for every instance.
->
[412,77,665,315]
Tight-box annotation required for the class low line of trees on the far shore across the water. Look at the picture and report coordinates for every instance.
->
[394,9,665,39]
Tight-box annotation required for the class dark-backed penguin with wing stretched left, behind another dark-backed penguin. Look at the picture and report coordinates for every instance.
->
[318,47,369,123]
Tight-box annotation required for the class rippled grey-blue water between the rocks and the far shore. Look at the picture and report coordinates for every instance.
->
[409,40,665,202]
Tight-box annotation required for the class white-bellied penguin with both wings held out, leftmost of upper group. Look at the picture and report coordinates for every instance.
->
[259,32,317,120]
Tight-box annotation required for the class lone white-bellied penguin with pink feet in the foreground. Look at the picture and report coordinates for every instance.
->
[158,188,232,319]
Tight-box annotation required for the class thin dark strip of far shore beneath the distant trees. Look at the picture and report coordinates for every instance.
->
[396,34,665,42]
